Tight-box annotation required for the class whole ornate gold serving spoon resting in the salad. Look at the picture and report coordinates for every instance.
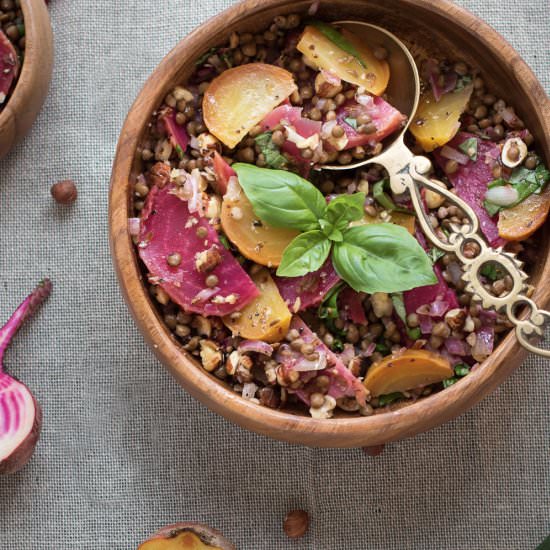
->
[322,21,550,357]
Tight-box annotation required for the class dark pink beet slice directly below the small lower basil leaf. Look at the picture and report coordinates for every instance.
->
[274,259,340,313]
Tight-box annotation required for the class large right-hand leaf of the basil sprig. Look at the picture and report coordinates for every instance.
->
[332,223,437,294]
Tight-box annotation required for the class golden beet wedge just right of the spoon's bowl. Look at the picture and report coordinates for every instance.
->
[410,85,474,153]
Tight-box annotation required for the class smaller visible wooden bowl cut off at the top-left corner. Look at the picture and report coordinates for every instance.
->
[0,0,53,159]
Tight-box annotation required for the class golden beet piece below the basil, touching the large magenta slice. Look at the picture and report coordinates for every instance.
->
[222,269,292,343]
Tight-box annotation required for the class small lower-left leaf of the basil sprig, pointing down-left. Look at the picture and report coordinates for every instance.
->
[277,231,330,277]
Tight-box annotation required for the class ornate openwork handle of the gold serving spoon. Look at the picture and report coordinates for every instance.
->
[406,156,550,358]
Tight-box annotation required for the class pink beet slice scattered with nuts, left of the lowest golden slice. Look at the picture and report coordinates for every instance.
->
[277,315,367,406]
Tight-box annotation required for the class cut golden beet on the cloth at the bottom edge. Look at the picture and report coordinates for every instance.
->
[138,523,235,550]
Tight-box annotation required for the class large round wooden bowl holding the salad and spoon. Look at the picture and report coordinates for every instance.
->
[109,0,550,447]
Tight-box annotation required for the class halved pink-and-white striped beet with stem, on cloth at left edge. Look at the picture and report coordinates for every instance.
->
[0,279,52,474]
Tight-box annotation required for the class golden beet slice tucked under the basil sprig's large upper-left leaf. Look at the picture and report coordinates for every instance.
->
[221,184,298,267]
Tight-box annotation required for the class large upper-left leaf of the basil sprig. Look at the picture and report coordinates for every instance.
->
[232,163,327,231]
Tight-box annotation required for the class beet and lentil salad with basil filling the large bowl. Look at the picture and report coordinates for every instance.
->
[129,15,550,418]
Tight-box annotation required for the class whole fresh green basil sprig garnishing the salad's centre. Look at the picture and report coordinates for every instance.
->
[233,163,437,294]
